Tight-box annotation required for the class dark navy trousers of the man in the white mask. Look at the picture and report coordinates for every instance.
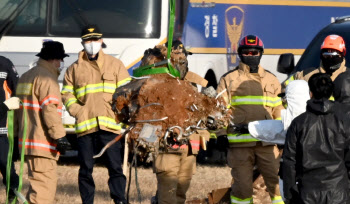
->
[78,130,126,204]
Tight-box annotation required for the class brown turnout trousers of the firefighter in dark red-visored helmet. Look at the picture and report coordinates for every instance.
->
[227,144,284,204]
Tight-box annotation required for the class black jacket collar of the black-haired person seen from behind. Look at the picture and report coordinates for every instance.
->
[306,98,334,115]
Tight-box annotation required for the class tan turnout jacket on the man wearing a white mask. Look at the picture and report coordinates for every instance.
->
[61,50,131,137]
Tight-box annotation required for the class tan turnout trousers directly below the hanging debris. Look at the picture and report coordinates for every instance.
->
[154,148,196,204]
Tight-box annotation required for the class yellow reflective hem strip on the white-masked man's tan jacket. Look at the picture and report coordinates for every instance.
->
[75,116,122,133]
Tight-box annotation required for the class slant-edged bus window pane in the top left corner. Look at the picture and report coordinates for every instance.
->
[6,0,47,36]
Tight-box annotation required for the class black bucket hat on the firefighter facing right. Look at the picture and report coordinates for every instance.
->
[36,41,69,60]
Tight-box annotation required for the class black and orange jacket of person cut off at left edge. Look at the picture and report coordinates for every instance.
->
[0,56,19,137]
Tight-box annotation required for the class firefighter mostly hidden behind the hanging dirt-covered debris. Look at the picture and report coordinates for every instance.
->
[153,40,209,204]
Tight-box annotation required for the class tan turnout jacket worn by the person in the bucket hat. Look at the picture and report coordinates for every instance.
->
[15,59,66,160]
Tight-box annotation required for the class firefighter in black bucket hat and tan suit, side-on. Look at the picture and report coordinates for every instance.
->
[15,41,70,203]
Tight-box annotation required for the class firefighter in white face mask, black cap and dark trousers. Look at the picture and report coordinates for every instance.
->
[61,25,131,203]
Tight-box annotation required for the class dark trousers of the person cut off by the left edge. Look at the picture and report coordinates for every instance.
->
[0,136,18,196]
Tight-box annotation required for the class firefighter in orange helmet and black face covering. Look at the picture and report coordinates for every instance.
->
[282,35,347,89]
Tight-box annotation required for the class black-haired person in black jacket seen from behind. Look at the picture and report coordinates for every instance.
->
[282,73,350,204]
